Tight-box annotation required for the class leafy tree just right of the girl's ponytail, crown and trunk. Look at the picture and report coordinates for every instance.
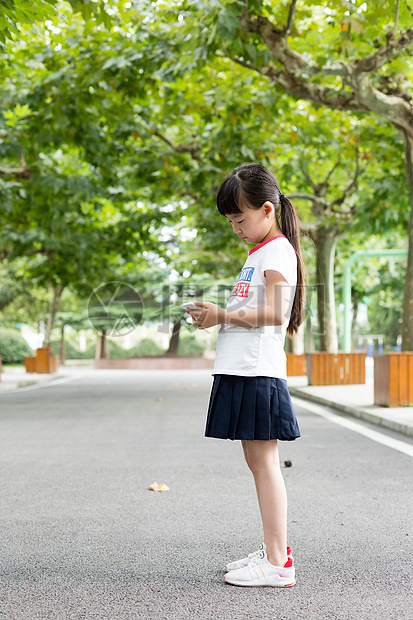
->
[283,109,408,351]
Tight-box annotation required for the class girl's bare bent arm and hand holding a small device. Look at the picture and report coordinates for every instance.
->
[190,270,293,329]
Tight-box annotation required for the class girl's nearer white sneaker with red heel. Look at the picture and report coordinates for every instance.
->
[224,550,295,588]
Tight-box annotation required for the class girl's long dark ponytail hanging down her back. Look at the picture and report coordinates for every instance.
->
[280,194,307,338]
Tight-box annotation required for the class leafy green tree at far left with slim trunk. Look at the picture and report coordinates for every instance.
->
[0,18,171,344]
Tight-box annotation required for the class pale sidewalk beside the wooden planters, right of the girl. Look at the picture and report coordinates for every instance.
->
[288,377,413,437]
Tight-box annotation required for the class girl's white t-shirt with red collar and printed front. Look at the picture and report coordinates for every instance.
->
[212,235,297,379]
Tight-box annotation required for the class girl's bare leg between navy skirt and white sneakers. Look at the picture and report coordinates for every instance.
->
[242,439,287,566]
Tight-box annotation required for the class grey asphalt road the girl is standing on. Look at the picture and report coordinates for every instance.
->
[0,371,413,620]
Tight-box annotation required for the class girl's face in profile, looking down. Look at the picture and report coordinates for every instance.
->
[225,202,281,245]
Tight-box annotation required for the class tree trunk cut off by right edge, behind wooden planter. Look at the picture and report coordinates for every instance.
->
[398,128,413,351]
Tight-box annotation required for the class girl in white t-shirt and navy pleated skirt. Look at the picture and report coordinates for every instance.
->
[188,163,305,587]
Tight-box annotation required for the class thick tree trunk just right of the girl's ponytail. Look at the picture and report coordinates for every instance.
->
[311,226,338,353]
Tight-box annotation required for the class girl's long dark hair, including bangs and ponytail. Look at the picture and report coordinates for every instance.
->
[217,163,306,337]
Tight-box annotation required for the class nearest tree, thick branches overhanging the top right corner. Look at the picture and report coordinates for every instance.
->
[138,0,413,350]
